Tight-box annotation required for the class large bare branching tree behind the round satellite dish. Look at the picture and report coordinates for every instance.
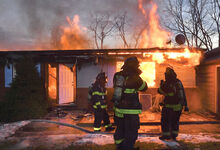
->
[166,0,214,50]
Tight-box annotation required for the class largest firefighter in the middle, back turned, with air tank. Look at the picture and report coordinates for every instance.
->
[112,57,148,150]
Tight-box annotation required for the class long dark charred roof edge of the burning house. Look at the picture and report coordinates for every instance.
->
[0,47,201,63]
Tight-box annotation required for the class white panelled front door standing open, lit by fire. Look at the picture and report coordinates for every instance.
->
[59,64,75,104]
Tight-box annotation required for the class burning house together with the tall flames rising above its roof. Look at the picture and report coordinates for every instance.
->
[0,0,215,114]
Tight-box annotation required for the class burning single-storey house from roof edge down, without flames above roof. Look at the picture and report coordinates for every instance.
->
[0,48,202,110]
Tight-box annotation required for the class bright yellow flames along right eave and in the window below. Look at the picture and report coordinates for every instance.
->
[114,48,202,87]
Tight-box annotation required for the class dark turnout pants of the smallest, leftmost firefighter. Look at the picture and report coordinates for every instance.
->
[93,108,110,130]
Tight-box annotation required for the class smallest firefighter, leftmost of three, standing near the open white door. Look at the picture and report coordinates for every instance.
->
[88,72,114,132]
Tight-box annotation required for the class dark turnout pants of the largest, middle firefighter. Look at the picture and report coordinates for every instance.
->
[114,115,140,150]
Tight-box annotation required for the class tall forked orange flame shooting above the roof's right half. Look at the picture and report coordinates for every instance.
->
[138,0,171,48]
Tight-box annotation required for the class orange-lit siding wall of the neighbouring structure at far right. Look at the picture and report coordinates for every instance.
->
[196,64,216,113]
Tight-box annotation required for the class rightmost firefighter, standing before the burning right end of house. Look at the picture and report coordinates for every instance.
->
[158,67,189,140]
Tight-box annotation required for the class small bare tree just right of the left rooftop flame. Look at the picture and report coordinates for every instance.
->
[88,13,115,49]
